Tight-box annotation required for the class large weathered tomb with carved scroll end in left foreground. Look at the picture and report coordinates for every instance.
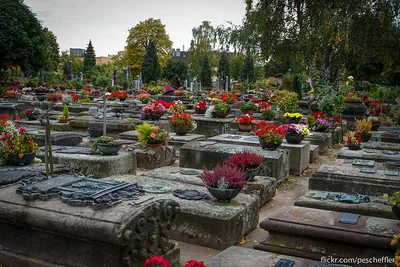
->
[0,176,179,266]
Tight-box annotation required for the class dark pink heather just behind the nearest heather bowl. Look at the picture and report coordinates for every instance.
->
[225,150,264,181]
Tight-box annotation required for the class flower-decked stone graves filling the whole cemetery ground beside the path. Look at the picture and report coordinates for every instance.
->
[0,81,400,266]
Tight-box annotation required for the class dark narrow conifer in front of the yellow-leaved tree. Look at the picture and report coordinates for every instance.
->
[142,39,161,83]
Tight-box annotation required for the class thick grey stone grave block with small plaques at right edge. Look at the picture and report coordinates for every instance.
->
[309,164,400,196]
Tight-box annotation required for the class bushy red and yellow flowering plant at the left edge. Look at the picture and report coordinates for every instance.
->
[0,120,39,161]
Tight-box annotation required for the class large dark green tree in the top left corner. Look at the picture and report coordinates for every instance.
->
[0,0,47,74]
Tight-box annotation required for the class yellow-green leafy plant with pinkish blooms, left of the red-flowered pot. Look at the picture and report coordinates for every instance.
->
[136,122,169,148]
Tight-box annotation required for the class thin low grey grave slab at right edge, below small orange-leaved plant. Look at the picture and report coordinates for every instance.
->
[338,147,400,162]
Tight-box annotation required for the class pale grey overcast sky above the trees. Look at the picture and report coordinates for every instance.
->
[24,0,245,56]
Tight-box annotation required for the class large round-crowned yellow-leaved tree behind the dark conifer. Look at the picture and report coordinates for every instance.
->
[122,18,172,75]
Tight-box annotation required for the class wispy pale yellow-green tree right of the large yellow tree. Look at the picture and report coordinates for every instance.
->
[188,21,217,76]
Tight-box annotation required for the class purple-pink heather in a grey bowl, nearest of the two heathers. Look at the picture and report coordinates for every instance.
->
[200,164,246,202]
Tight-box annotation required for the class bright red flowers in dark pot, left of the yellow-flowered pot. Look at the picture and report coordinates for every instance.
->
[256,121,286,150]
